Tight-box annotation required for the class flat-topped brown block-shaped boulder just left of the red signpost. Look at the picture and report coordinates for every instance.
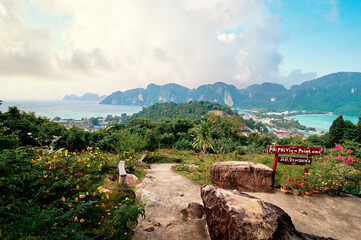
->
[211,161,273,193]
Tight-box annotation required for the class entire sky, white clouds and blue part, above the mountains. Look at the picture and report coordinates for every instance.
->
[0,0,361,101]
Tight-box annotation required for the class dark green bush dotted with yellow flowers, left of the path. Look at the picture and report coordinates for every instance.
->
[0,148,144,239]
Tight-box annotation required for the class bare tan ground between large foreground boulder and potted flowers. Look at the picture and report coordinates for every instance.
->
[248,190,361,240]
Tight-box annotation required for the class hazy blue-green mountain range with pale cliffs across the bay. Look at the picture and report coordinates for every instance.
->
[101,72,361,116]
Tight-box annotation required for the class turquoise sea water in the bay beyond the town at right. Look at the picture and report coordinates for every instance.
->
[291,114,358,132]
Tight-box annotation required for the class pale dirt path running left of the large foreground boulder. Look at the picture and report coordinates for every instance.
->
[133,164,209,240]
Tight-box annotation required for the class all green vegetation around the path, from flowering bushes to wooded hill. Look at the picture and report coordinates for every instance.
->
[0,102,361,239]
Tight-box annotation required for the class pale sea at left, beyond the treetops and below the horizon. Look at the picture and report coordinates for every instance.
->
[0,100,143,119]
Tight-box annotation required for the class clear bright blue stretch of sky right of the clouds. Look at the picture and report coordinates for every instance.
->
[272,0,361,76]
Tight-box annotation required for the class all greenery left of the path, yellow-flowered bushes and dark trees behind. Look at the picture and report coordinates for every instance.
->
[0,107,145,239]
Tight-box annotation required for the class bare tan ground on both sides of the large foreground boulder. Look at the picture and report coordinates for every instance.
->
[133,164,361,240]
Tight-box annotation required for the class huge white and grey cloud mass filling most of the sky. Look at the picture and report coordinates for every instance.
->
[0,0,306,99]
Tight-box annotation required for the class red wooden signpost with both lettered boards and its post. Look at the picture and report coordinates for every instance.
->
[267,145,323,183]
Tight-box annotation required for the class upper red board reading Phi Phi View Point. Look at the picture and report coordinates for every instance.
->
[267,145,323,156]
